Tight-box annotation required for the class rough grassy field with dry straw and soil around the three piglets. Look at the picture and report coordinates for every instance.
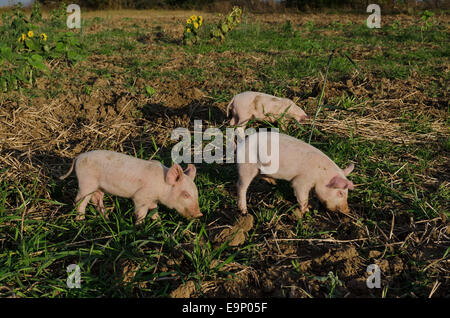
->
[0,9,450,297]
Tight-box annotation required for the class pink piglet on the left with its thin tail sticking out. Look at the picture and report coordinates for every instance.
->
[60,150,202,225]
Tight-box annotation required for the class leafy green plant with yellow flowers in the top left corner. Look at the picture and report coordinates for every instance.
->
[0,2,83,92]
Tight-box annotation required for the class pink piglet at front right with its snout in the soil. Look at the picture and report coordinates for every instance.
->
[237,132,354,217]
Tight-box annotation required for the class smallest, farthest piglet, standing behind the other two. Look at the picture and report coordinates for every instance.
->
[227,91,309,127]
